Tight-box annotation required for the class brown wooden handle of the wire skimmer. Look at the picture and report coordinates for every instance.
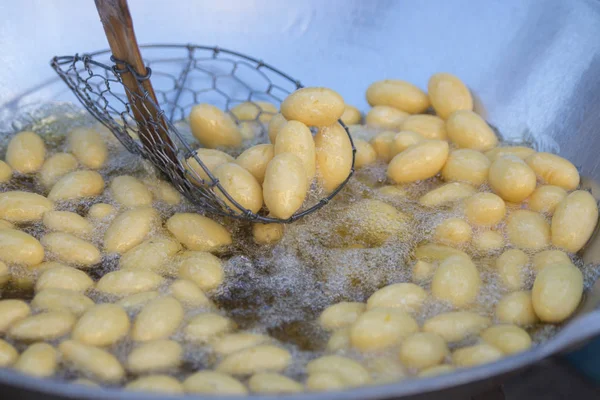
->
[95,0,178,164]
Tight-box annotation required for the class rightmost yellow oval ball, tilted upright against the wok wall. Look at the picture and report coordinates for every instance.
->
[550,190,598,253]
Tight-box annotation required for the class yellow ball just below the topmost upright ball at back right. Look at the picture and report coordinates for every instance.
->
[446,110,498,151]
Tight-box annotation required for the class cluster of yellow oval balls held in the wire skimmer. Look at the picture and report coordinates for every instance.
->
[187,88,352,219]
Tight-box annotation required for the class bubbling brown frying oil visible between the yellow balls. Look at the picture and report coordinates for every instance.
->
[0,105,600,388]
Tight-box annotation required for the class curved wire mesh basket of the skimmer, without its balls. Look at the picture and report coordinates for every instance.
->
[50,44,356,223]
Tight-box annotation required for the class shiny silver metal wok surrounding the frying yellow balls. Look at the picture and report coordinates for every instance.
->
[0,0,600,400]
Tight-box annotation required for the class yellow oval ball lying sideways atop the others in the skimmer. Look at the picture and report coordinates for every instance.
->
[281,87,345,126]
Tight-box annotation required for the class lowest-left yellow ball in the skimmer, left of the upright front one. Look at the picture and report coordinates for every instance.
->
[213,163,263,213]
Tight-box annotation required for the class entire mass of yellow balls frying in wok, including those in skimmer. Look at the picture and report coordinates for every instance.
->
[0,73,598,395]
